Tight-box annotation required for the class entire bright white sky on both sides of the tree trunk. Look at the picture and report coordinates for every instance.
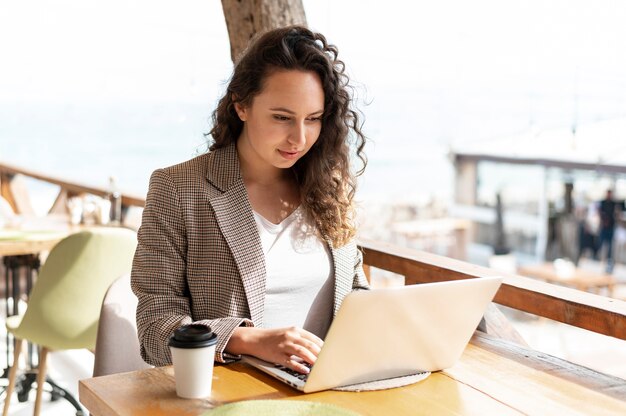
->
[0,0,626,111]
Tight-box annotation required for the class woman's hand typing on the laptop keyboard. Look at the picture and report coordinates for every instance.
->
[226,327,324,374]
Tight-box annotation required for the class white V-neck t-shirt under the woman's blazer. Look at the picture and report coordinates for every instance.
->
[253,207,334,338]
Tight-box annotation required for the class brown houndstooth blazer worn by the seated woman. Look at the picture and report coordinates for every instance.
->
[131,145,367,366]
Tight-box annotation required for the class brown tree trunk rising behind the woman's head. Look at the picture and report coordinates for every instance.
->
[222,0,306,62]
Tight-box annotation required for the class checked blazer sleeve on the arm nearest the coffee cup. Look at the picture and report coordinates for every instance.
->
[131,169,253,366]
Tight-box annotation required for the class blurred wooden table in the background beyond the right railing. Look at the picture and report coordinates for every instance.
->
[517,262,616,296]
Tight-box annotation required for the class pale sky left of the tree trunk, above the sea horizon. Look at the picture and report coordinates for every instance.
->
[0,0,231,102]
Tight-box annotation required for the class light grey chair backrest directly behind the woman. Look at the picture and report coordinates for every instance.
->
[93,274,150,377]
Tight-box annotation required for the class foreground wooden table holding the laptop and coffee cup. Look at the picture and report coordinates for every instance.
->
[79,332,626,416]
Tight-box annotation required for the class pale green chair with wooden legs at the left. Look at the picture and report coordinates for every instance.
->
[3,227,137,416]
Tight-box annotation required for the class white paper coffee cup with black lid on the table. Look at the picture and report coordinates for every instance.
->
[169,324,217,399]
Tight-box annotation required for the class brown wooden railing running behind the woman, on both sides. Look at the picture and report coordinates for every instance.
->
[0,159,626,340]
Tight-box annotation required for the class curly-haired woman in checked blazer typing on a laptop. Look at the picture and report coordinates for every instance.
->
[132,26,367,373]
